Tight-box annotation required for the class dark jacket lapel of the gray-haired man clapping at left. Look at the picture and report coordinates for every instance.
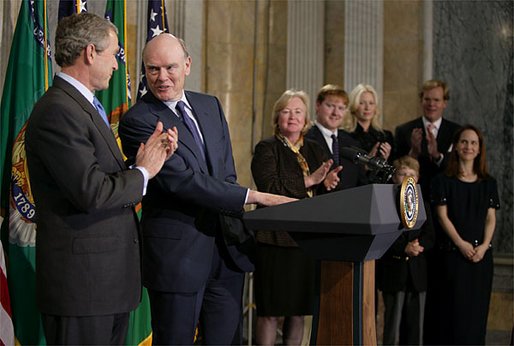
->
[53,77,126,169]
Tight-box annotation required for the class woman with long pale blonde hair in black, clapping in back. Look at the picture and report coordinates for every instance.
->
[350,84,393,160]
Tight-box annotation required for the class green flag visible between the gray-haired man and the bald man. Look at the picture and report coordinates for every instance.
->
[96,0,152,345]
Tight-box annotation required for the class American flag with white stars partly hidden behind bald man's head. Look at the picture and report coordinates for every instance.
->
[137,0,169,100]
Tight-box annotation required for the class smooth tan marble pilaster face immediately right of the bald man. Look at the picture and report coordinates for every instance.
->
[204,0,256,186]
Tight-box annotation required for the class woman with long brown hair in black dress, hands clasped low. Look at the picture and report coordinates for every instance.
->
[432,125,500,345]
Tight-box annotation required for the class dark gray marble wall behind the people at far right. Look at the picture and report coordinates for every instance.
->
[434,1,514,254]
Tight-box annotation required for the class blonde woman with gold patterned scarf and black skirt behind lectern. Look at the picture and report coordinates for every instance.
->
[252,90,341,345]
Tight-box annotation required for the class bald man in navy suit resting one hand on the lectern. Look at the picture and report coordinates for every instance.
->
[119,34,291,345]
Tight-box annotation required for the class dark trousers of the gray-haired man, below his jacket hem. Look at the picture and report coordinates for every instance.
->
[42,312,129,345]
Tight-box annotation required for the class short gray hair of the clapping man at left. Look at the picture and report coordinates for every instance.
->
[55,12,118,67]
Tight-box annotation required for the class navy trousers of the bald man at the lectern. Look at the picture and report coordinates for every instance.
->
[148,242,244,345]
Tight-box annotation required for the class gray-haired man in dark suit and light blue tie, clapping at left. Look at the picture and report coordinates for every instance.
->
[25,13,177,345]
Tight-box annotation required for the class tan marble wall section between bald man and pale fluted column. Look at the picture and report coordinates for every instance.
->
[204,0,288,186]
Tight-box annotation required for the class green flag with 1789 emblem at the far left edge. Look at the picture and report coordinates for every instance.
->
[0,0,52,345]
